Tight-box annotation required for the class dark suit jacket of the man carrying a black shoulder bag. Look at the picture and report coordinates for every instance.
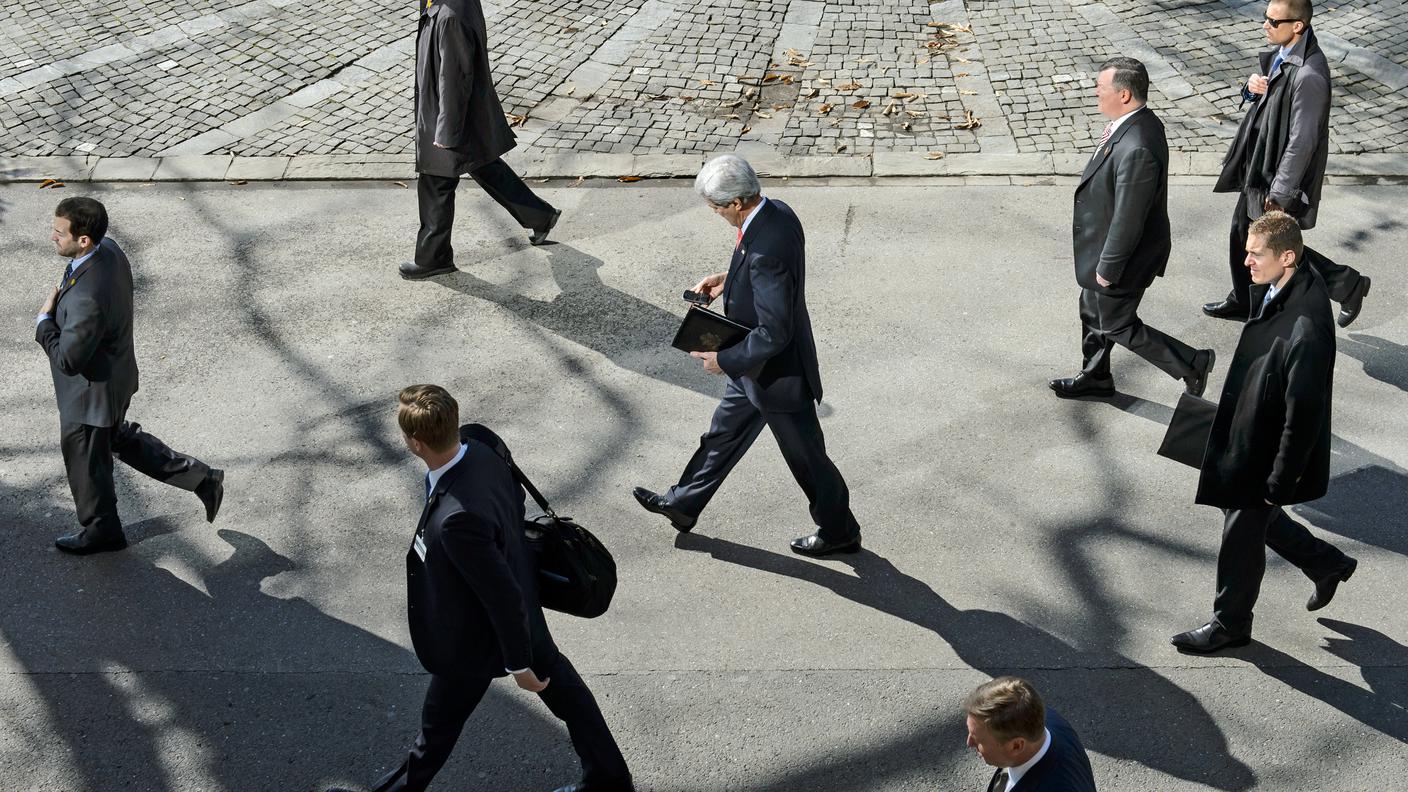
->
[406,422,558,676]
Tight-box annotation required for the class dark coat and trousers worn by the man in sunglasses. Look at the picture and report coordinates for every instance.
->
[1214,30,1360,304]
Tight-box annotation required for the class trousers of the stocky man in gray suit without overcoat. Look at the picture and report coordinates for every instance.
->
[1080,289,1197,379]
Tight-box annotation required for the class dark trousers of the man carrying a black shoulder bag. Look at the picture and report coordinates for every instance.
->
[372,652,631,792]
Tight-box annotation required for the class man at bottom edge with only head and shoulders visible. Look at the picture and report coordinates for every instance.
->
[963,676,1095,792]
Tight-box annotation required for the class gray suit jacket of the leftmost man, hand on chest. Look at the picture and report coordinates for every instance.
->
[34,237,137,427]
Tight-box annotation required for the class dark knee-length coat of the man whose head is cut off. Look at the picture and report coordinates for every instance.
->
[415,0,515,176]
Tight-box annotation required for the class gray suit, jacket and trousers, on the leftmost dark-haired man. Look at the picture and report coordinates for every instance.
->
[34,238,210,536]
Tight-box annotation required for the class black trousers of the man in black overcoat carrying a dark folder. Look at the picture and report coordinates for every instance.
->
[1212,506,1347,634]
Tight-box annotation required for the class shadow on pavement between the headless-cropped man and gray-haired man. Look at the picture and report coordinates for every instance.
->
[436,242,724,399]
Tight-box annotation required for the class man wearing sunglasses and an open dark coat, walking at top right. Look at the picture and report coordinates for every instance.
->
[1202,0,1370,327]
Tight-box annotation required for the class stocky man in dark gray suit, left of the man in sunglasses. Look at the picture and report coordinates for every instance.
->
[1049,58,1214,399]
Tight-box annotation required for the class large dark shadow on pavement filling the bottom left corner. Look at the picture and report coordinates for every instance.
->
[0,485,576,792]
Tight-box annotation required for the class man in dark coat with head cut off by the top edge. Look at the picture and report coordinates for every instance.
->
[400,0,562,280]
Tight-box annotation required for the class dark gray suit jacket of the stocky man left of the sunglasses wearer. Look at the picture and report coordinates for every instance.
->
[1071,107,1173,293]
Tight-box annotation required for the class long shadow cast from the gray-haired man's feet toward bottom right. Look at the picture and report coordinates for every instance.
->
[674,534,1256,791]
